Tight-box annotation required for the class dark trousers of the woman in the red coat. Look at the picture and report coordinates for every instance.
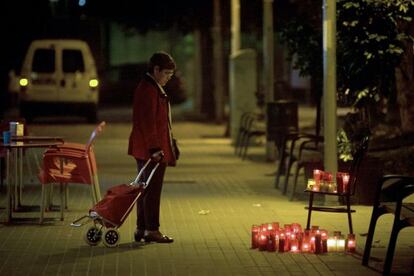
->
[136,159,167,231]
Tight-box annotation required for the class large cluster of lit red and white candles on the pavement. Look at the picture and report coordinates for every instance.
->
[251,222,356,254]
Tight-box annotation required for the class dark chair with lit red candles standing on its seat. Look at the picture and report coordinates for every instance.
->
[305,136,369,234]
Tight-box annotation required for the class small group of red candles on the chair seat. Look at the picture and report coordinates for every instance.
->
[307,170,349,194]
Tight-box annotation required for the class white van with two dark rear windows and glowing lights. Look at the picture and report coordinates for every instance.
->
[19,39,99,122]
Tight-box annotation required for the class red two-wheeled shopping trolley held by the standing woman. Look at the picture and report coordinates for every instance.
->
[71,159,159,247]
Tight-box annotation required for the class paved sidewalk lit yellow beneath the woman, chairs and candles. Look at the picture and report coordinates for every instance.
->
[0,117,414,276]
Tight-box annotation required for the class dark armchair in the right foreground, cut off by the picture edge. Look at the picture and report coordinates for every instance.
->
[362,175,414,275]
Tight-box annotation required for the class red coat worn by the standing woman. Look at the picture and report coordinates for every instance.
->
[128,75,176,166]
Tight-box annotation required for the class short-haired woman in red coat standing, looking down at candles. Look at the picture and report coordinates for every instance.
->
[128,52,178,243]
